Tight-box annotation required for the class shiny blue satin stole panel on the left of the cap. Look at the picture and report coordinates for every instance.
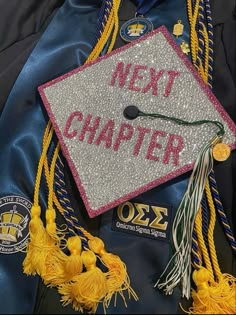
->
[0,1,98,314]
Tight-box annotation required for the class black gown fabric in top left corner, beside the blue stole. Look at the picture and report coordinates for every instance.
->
[0,0,63,114]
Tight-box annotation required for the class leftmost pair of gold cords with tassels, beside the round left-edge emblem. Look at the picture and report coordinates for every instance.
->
[23,123,66,286]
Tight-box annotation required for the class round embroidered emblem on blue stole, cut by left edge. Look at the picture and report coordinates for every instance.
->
[0,196,32,254]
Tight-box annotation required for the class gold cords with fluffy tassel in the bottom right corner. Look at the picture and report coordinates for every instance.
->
[188,182,236,314]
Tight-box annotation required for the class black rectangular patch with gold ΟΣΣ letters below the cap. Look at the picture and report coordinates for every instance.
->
[112,201,172,241]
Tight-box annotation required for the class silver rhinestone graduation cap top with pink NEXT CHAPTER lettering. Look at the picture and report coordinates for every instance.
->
[39,27,236,217]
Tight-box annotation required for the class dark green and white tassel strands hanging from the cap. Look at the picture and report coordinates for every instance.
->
[155,136,219,299]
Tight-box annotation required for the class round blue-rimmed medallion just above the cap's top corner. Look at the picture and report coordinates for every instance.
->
[120,17,153,42]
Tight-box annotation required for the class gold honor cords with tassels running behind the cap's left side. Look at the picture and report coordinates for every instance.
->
[23,0,138,313]
